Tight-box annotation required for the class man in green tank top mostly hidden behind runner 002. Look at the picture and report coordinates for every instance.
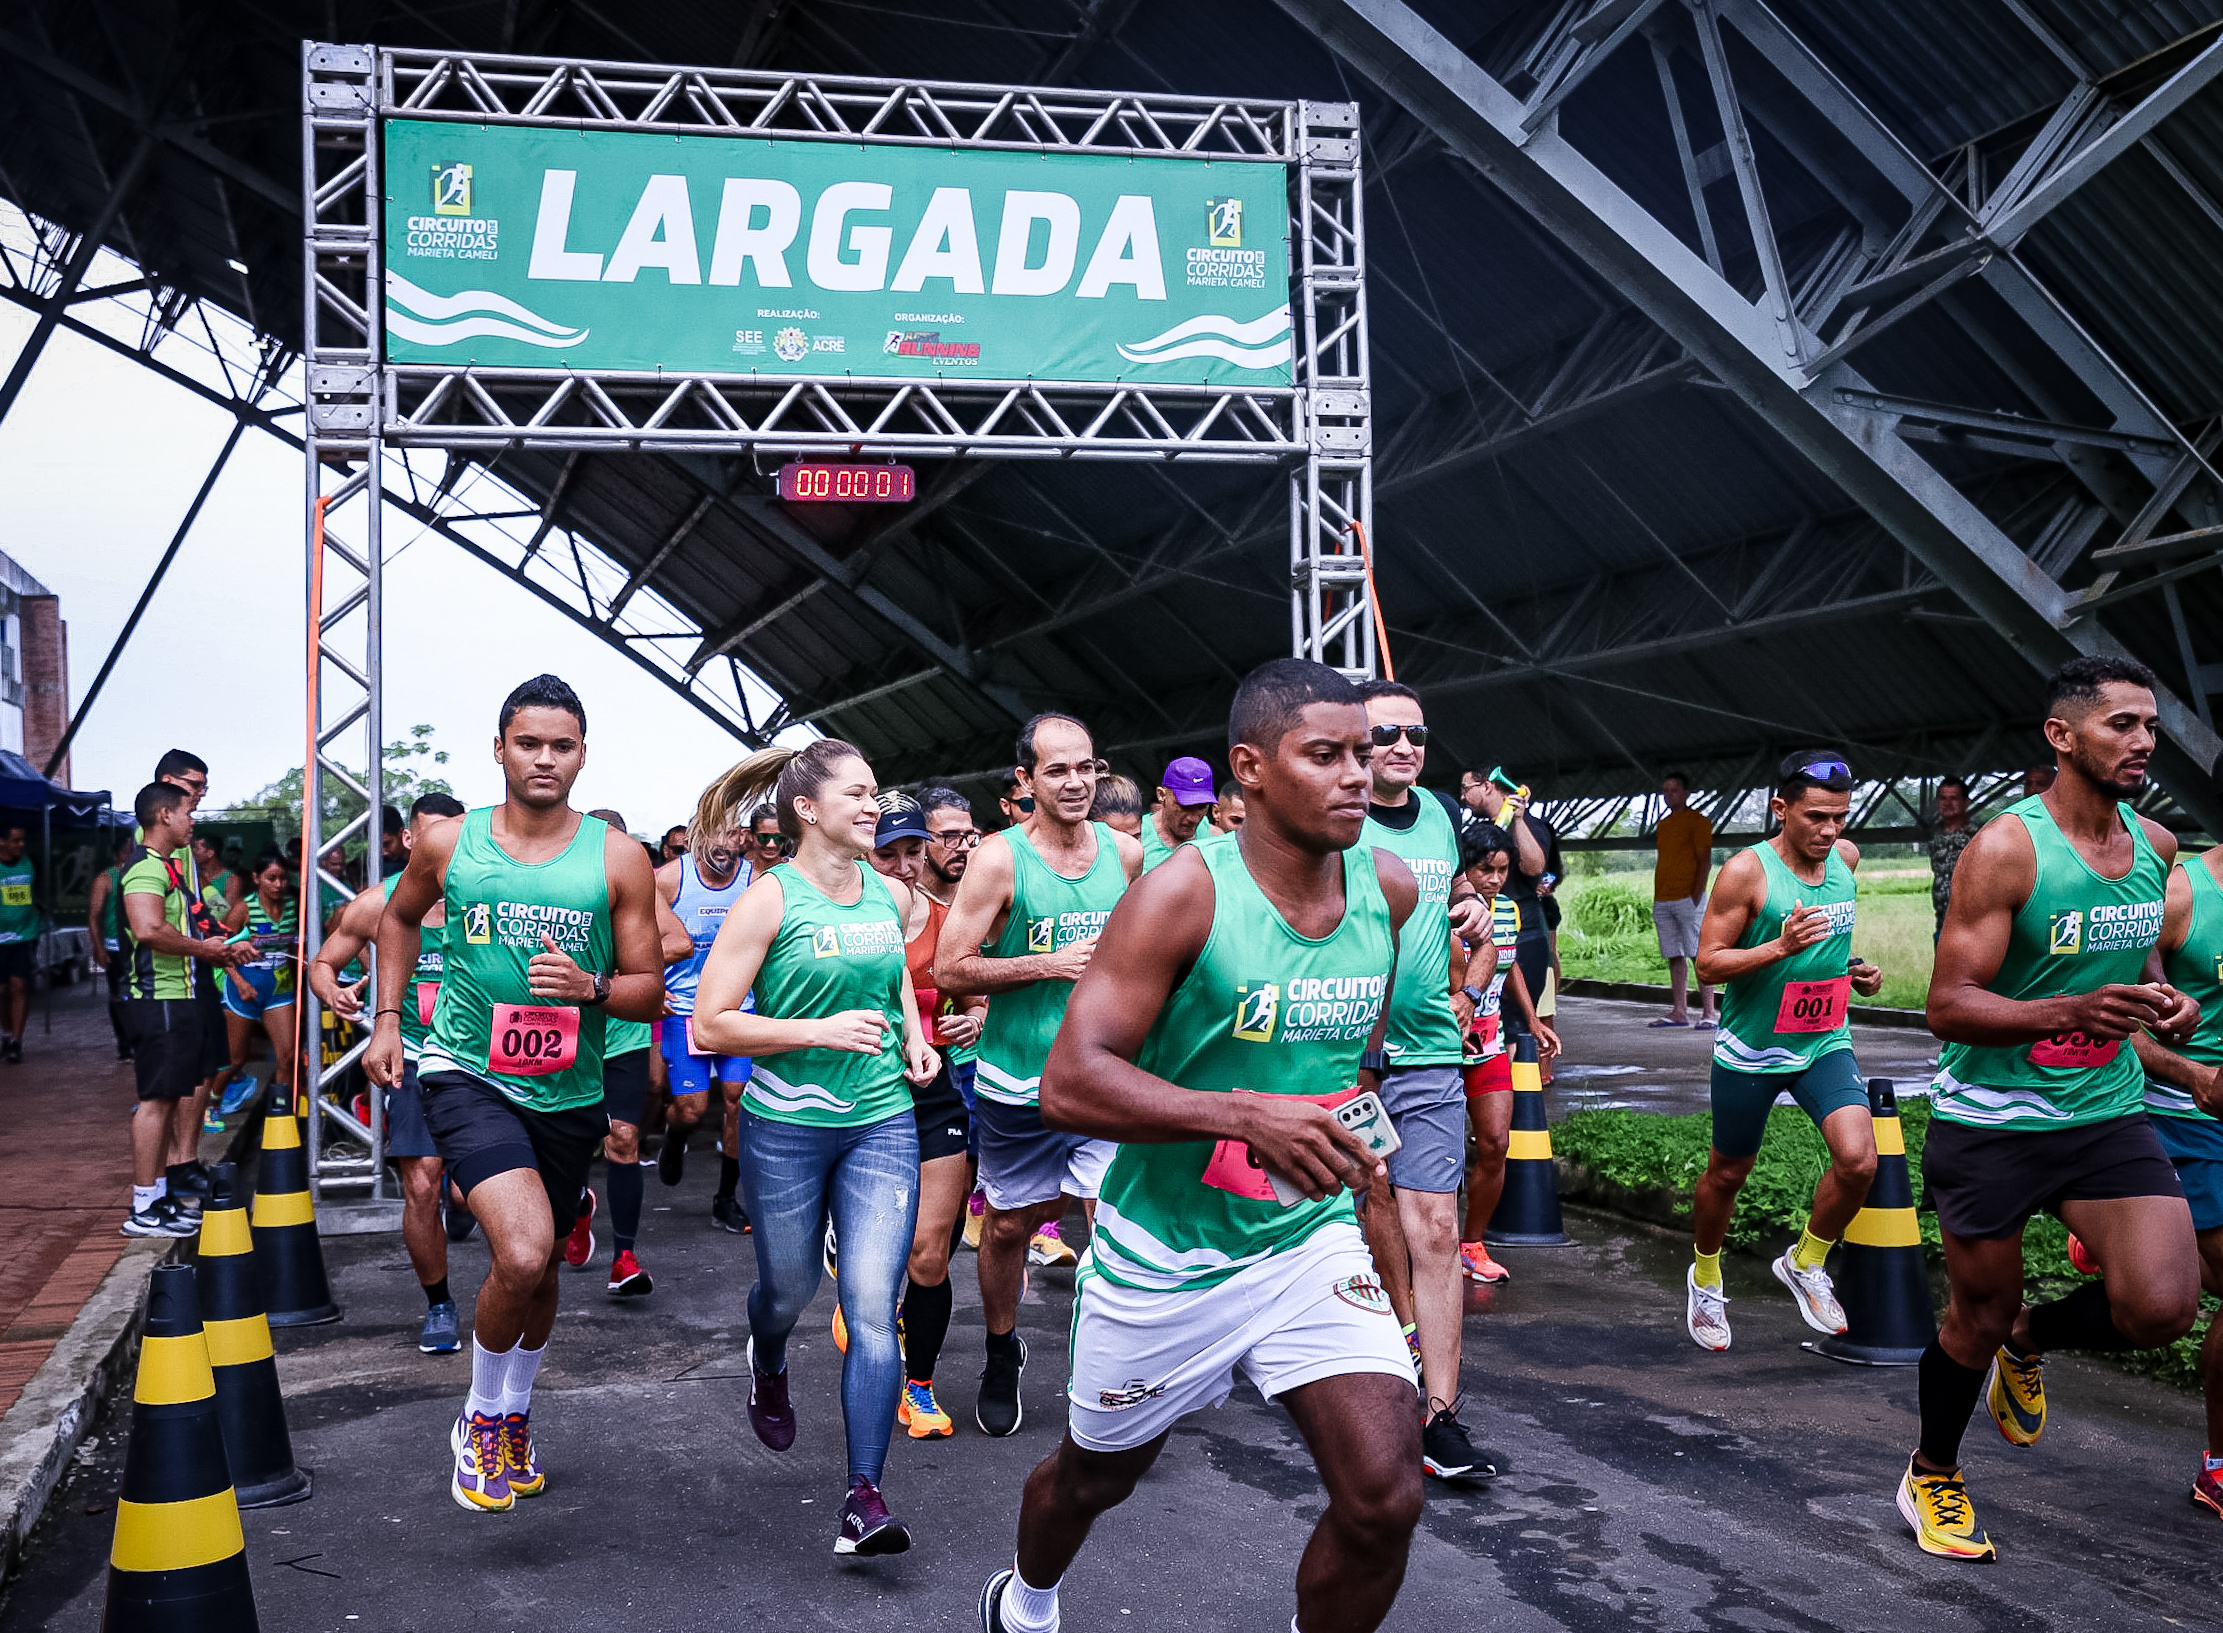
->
[309,793,465,1355]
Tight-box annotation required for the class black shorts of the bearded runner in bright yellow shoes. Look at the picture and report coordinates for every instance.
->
[1923,1111,2185,1242]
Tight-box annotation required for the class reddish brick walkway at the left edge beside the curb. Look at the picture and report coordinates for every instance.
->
[0,982,136,1413]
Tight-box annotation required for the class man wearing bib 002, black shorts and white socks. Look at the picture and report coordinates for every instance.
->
[365,675,665,1511]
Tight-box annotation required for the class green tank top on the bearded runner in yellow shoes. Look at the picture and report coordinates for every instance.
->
[1936,795,2167,1129]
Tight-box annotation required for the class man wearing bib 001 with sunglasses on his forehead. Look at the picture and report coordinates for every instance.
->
[1683,749,1883,1351]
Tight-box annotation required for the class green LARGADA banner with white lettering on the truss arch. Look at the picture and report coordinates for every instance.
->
[385,120,1292,387]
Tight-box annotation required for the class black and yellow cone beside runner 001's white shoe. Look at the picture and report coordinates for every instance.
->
[1805,1078,1938,1366]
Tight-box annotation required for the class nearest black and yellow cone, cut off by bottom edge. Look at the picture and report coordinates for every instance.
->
[100,1264,256,1633]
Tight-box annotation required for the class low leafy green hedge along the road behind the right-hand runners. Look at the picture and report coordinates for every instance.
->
[1552,1100,2216,1389]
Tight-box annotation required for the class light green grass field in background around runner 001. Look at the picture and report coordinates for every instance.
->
[1558,858,1936,1009]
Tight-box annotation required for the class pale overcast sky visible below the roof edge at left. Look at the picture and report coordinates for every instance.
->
[0,299,769,833]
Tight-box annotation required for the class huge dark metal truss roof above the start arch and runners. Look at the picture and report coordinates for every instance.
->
[0,0,2223,833]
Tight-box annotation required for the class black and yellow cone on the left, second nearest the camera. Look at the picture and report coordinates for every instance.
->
[193,1162,309,1509]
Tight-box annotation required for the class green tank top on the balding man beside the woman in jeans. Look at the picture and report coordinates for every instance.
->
[974,822,1127,1106]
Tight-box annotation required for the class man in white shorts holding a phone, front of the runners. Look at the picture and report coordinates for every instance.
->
[980,658,1420,1633]
